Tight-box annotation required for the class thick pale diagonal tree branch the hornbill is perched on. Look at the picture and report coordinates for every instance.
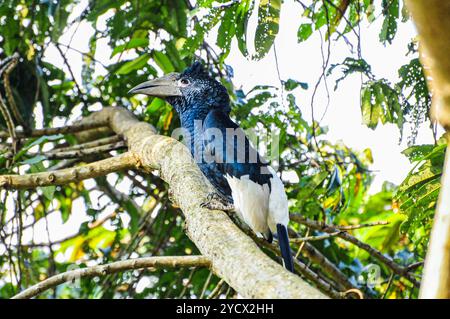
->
[77,107,326,298]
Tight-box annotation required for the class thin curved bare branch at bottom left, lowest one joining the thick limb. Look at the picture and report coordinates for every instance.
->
[12,256,211,299]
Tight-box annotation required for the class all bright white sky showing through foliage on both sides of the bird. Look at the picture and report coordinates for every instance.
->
[2,0,440,250]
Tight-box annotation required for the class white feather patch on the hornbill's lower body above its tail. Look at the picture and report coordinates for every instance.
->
[225,166,289,238]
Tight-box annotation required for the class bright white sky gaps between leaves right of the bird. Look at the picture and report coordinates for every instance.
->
[226,1,440,193]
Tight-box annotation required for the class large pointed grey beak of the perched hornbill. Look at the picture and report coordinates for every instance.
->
[128,73,182,98]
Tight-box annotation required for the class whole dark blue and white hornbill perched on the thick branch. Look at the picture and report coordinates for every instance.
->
[130,62,294,271]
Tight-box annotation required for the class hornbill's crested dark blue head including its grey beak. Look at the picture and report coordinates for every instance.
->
[129,62,230,114]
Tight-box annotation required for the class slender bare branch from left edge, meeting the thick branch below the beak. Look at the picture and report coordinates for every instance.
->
[0,152,138,189]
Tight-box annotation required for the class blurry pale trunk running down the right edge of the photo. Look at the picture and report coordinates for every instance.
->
[406,0,450,298]
